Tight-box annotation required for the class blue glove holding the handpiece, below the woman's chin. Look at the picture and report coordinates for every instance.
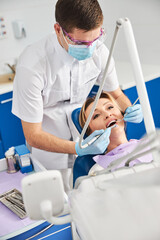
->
[75,128,111,156]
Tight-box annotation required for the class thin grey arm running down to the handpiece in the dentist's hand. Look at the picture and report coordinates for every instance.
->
[79,23,121,149]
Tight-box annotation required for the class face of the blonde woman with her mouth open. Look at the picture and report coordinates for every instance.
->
[85,98,124,132]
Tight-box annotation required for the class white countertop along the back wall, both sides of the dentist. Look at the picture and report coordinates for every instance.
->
[0,62,160,94]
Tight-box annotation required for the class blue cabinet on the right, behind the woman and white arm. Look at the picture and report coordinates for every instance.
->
[123,78,160,140]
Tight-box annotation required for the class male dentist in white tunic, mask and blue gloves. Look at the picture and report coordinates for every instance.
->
[12,0,143,189]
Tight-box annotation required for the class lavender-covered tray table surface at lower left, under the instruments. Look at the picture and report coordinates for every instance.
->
[0,155,46,240]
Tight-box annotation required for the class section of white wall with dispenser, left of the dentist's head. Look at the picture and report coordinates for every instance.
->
[0,0,56,74]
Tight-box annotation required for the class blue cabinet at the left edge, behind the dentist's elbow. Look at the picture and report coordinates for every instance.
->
[0,91,25,158]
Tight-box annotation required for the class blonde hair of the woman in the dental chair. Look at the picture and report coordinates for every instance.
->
[79,92,124,135]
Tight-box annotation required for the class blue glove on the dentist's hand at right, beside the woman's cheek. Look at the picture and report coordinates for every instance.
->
[124,104,143,123]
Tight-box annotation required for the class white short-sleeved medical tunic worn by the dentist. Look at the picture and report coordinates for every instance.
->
[12,34,119,169]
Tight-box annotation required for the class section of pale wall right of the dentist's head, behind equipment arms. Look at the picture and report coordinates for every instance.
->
[100,0,160,66]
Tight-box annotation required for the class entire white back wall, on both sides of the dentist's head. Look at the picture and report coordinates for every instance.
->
[0,0,160,74]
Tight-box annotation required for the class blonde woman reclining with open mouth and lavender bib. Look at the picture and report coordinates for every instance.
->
[79,92,153,174]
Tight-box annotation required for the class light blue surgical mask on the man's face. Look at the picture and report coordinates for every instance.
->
[68,41,97,61]
